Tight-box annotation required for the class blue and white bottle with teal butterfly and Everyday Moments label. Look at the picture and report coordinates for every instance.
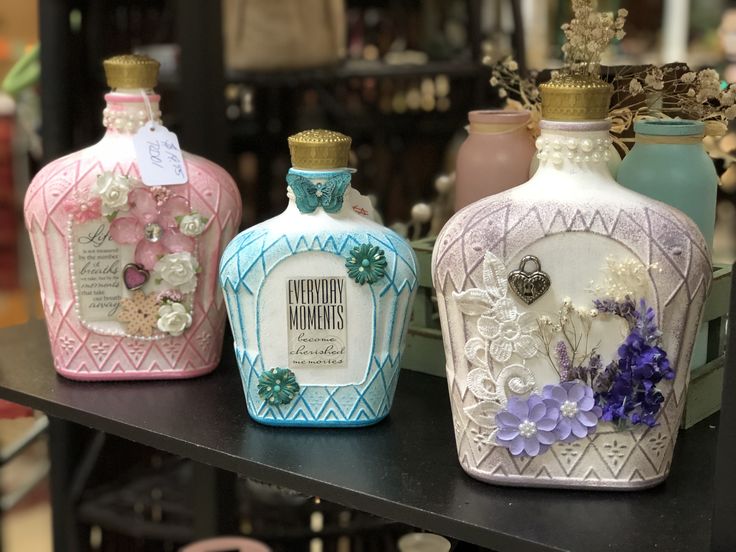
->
[220,130,417,427]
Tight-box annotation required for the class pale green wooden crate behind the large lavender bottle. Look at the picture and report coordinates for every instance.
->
[401,238,732,428]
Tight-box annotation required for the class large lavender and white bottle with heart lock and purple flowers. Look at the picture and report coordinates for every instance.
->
[433,75,711,489]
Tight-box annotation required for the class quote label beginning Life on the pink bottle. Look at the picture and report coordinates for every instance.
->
[72,219,123,322]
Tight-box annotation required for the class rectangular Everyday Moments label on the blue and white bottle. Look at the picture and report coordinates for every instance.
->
[286,277,347,368]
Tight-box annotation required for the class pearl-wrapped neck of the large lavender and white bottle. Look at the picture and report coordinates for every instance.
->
[536,120,612,173]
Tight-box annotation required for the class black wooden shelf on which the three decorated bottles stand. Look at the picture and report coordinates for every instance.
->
[0,321,717,552]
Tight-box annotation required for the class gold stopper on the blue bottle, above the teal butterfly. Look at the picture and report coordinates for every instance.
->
[289,129,352,170]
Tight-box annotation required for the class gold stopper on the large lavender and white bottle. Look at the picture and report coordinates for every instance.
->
[539,75,613,121]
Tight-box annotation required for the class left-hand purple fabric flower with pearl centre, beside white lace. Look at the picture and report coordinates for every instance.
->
[496,394,560,456]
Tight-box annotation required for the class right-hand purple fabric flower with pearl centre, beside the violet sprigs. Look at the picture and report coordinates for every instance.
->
[542,381,602,441]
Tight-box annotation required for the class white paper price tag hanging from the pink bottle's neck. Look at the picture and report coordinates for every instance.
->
[133,121,188,186]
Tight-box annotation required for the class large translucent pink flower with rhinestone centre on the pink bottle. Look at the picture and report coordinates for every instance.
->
[110,188,194,270]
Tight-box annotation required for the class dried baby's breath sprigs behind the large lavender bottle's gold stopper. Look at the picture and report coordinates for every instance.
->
[484,0,736,154]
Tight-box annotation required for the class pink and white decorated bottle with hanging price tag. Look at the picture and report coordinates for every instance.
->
[25,55,241,380]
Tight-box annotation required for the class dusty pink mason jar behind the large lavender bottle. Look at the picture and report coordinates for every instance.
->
[455,109,535,211]
